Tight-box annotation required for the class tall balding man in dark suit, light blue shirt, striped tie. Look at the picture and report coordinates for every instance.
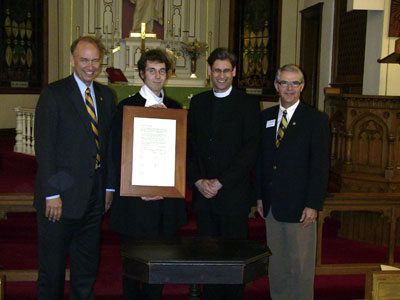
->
[34,37,115,300]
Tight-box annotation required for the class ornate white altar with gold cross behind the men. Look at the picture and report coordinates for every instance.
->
[73,0,220,88]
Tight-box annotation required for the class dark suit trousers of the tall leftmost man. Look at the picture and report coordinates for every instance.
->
[37,171,104,300]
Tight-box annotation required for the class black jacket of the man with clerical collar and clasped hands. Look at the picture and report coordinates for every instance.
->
[187,89,260,215]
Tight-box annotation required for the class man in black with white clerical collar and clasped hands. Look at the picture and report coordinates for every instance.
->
[187,48,260,300]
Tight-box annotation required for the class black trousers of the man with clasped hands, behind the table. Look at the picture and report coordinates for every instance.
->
[196,211,248,300]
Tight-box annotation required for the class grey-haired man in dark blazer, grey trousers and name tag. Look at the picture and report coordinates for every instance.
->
[256,65,330,300]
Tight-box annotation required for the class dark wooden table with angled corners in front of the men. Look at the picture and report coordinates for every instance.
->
[121,237,271,299]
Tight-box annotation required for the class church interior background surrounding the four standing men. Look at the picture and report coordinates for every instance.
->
[0,0,400,300]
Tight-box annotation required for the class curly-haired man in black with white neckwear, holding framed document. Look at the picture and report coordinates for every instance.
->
[110,49,186,300]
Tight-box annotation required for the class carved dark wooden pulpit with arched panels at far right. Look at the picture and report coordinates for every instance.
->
[325,93,400,193]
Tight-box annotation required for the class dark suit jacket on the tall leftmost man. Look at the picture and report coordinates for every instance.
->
[34,75,115,218]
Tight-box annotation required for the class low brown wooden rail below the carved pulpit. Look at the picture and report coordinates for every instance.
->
[316,193,400,274]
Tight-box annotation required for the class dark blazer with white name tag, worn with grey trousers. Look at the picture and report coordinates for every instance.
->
[255,102,330,222]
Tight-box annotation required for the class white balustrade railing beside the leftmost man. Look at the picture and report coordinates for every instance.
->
[14,107,35,155]
